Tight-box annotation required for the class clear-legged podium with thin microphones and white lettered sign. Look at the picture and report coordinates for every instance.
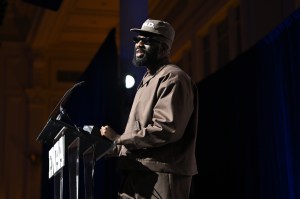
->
[37,83,114,199]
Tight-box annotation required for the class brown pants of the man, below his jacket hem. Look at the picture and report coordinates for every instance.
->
[119,171,192,199]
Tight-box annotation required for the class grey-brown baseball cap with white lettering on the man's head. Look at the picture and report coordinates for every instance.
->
[130,19,175,49]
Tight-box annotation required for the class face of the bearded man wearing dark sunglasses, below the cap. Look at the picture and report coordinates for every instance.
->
[132,35,160,67]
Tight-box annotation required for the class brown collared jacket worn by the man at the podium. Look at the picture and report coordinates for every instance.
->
[117,64,198,175]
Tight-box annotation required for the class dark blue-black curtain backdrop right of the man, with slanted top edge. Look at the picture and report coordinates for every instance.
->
[190,7,300,199]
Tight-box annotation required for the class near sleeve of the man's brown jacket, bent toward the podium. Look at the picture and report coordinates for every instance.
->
[117,76,194,149]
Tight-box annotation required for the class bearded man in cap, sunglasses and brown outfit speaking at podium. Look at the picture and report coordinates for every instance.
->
[100,19,198,199]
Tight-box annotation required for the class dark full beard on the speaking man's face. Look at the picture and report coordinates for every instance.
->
[132,46,159,67]
